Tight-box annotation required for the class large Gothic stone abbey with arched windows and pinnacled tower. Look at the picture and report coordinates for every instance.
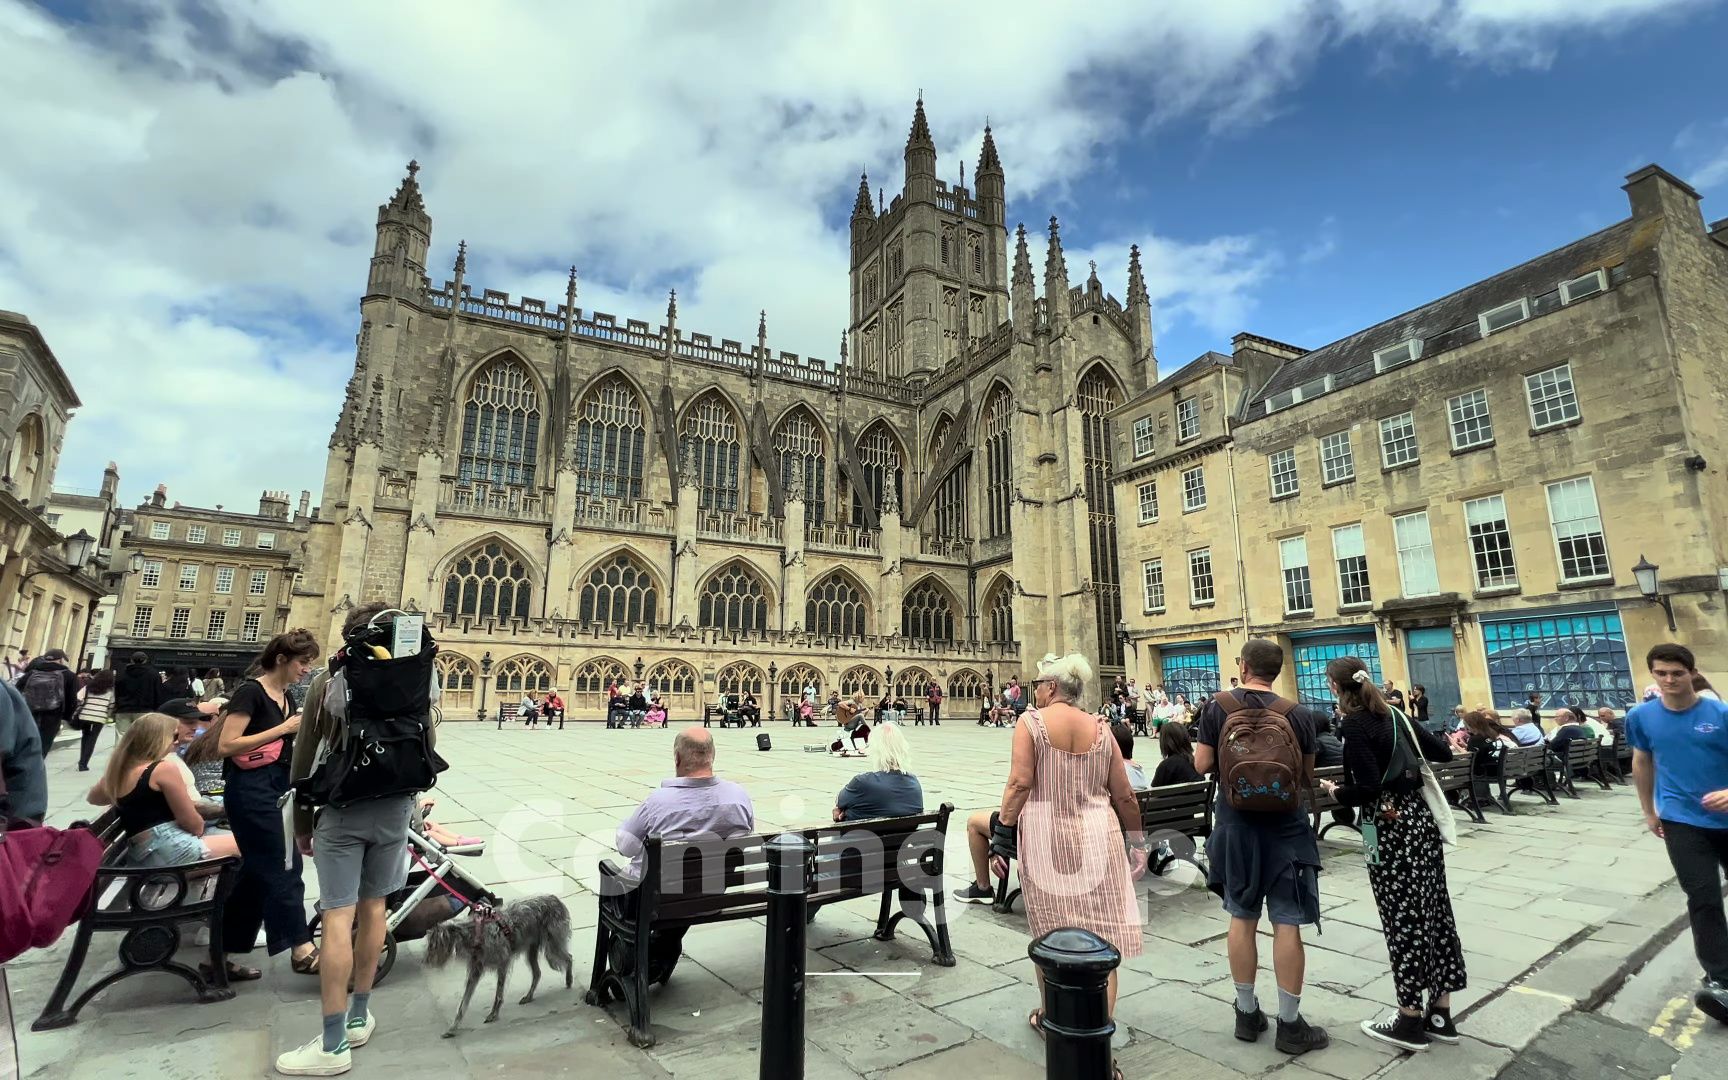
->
[295,102,1156,715]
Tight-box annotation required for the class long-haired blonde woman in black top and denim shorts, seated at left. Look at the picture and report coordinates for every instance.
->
[90,712,240,866]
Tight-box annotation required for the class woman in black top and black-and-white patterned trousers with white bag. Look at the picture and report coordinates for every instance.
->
[1320,657,1465,1051]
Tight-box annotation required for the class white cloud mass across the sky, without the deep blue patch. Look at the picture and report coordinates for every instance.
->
[0,0,1692,505]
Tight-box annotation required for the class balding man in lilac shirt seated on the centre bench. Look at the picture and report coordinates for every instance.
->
[617,727,755,888]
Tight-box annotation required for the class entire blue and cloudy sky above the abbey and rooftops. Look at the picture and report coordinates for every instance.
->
[0,0,1728,506]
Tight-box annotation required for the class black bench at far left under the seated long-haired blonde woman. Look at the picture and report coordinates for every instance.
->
[29,810,240,1032]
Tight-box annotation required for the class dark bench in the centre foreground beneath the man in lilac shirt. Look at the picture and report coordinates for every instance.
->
[584,804,954,1047]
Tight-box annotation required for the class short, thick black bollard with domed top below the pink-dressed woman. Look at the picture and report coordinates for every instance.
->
[1022,926,1121,1080]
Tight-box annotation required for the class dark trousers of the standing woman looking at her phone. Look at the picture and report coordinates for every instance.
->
[223,766,313,956]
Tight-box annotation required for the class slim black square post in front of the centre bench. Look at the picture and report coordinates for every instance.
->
[760,833,810,1080]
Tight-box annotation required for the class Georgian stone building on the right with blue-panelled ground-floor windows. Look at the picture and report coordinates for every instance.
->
[1115,166,1728,715]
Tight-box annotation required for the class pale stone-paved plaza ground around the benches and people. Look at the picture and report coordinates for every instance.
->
[7,724,1728,1080]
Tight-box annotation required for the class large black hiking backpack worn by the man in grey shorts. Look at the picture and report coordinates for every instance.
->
[295,624,449,809]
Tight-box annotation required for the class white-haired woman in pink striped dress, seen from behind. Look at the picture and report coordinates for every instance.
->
[1001,653,1146,1064]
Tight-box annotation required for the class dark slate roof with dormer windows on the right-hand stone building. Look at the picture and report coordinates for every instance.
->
[1246,218,1633,420]
